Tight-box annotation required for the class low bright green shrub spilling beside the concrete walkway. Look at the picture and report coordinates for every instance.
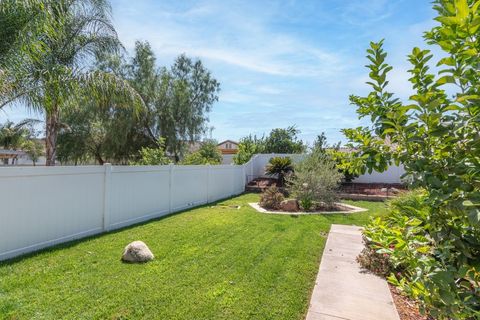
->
[358,190,480,319]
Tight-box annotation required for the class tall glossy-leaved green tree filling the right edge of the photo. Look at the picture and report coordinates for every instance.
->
[344,0,480,319]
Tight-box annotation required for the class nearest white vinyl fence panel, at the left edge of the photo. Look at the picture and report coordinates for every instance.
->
[0,167,104,260]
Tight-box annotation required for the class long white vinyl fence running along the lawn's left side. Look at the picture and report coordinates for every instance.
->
[0,165,246,260]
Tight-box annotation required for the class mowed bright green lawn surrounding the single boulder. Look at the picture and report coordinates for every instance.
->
[0,194,385,320]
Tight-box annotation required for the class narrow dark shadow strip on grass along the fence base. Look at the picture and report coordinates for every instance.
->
[0,192,249,268]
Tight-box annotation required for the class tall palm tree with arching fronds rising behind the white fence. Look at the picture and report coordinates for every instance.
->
[0,0,143,166]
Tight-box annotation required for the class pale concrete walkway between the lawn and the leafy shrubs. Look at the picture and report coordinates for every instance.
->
[307,225,400,320]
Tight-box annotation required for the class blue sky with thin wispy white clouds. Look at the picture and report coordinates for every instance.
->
[0,0,434,143]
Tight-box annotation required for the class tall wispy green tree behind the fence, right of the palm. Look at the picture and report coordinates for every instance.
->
[125,42,220,162]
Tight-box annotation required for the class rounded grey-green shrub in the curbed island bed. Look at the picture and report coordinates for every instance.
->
[288,150,342,210]
